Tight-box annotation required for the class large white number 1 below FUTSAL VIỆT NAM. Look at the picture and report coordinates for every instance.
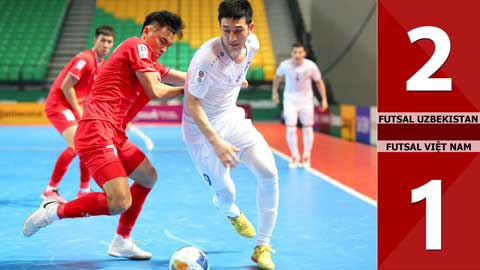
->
[412,180,442,250]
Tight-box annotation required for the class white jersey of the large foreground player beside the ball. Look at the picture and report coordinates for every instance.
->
[182,33,260,143]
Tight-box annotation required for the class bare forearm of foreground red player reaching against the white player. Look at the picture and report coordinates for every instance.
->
[135,71,183,99]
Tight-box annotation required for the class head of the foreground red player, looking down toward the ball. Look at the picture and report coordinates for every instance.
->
[142,10,185,58]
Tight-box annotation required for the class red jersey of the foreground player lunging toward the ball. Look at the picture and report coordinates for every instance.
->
[81,37,170,132]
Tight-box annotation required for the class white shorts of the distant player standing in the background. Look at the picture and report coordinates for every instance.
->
[283,99,314,126]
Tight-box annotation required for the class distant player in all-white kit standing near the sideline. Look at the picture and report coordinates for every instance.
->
[272,43,328,168]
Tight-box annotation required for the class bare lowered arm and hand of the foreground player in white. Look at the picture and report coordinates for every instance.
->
[185,93,240,168]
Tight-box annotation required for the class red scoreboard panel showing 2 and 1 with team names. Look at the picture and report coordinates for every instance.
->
[378,0,480,270]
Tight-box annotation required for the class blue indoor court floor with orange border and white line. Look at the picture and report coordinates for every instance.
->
[0,124,377,270]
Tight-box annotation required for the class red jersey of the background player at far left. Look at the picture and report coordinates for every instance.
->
[45,49,101,113]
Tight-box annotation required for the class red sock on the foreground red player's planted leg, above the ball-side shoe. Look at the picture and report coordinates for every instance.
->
[117,183,151,238]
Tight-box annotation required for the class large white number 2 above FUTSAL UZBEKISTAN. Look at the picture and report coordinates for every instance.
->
[407,26,452,91]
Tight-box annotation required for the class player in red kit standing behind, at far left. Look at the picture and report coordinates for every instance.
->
[41,25,115,203]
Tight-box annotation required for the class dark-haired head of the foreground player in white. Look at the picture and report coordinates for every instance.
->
[218,0,253,51]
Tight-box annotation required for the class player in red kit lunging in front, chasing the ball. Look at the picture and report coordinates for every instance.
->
[23,11,185,259]
